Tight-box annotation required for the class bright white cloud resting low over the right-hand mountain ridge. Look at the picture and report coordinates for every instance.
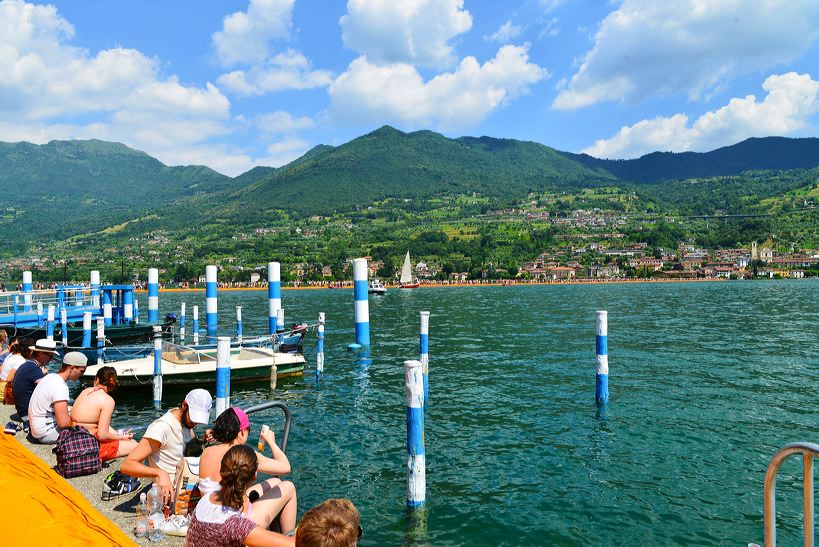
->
[583,72,819,158]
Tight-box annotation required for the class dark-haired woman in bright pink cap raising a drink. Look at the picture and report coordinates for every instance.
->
[199,406,297,532]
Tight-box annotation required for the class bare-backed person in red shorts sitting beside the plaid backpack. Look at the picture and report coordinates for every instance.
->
[71,367,137,462]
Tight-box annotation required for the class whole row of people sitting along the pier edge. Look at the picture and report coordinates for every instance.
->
[0,330,362,547]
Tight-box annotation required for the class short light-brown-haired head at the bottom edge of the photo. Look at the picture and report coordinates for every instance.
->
[296,499,364,547]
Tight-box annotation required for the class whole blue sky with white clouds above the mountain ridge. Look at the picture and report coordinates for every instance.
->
[0,0,819,176]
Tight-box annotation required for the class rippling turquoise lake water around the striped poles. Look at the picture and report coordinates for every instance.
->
[86,280,819,545]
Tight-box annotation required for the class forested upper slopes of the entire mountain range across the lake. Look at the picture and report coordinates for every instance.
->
[0,126,819,256]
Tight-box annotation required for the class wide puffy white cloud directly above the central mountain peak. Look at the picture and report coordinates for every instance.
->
[329,46,549,130]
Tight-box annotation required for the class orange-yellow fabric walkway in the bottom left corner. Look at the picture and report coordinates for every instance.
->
[0,432,136,547]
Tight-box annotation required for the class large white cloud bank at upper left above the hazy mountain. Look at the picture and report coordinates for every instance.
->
[0,0,270,174]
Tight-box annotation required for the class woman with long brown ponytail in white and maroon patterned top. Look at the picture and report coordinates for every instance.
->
[187,446,294,547]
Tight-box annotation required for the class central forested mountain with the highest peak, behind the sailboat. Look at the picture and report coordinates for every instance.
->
[227,126,615,214]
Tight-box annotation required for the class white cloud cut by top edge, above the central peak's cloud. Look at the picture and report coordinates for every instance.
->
[339,0,472,68]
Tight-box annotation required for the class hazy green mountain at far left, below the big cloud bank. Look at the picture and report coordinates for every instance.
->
[0,140,235,253]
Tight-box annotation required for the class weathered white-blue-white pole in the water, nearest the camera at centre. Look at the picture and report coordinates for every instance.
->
[404,361,427,507]
